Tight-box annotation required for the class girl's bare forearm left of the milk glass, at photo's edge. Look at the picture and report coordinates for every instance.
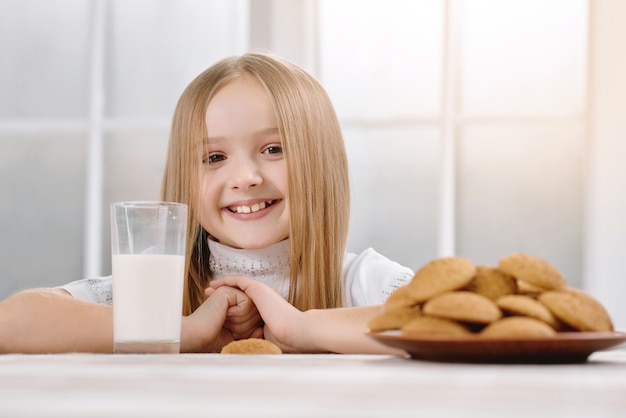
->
[0,289,113,354]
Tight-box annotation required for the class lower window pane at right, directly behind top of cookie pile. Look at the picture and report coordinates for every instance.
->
[450,123,584,287]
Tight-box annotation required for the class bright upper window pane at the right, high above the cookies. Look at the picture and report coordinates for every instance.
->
[461,0,587,116]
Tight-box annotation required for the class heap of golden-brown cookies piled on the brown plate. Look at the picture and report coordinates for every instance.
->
[368,253,613,338]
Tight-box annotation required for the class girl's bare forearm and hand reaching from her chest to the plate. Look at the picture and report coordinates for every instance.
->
[207,276,406,355]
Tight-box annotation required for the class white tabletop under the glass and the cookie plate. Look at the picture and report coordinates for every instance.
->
[0,348,626,418]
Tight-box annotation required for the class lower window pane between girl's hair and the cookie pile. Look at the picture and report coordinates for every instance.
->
[344,127,440,269]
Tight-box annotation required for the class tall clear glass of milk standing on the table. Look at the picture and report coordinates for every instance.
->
[111,202,187,353]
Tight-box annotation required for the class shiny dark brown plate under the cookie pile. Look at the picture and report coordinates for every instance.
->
[367,331,626,363]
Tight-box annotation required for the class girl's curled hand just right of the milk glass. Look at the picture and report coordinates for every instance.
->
[181,286,263,352]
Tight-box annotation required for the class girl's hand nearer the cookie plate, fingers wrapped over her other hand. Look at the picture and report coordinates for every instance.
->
[205,275,311,353]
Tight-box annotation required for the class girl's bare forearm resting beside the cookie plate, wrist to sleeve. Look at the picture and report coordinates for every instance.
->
[301,305,406,355]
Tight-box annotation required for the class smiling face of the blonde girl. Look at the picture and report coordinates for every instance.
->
[200,76,289,249]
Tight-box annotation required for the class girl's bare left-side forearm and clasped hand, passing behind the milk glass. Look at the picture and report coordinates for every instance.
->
[0,287,262,354]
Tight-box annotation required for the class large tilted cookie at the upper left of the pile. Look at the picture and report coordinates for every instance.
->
[406,257,476,303]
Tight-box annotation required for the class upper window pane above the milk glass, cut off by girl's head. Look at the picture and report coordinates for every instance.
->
[106,0,248,120]
